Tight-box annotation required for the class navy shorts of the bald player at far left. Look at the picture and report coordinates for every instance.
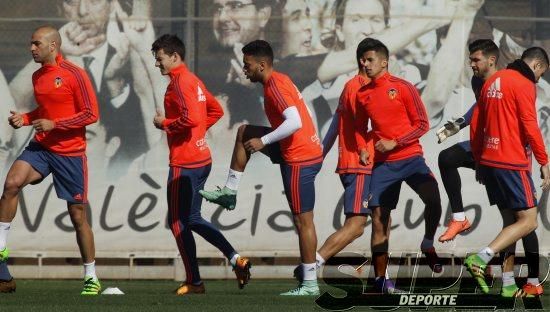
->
[17,142,88,204]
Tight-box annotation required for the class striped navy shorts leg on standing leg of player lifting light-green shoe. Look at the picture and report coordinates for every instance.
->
[280,162,323,215]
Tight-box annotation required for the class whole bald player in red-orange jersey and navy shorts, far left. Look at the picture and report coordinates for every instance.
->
[0,26,101,295]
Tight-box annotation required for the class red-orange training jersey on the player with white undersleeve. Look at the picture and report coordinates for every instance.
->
[264,71,323,164]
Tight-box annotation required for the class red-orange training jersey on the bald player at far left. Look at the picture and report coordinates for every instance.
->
[22,54,99,156]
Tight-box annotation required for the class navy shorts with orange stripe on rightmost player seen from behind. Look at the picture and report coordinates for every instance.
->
[478,165,537,210]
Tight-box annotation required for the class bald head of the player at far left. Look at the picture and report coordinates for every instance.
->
[31,26,61,64]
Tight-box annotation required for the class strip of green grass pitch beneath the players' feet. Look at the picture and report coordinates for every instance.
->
[0,280,550,312]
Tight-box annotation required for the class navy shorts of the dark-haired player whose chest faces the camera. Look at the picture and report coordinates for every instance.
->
[369,156,435,209]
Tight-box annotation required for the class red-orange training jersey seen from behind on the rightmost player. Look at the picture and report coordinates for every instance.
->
[470,69,548,170]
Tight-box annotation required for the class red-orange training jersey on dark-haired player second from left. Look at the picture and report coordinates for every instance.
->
[163,64,223,168]
